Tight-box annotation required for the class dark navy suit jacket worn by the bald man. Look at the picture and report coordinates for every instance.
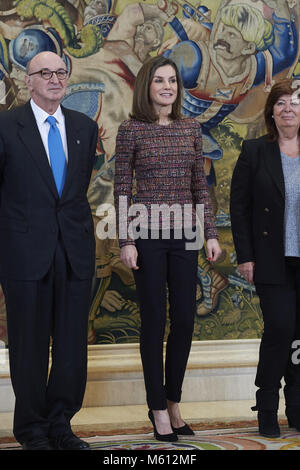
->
[0,102,98,280]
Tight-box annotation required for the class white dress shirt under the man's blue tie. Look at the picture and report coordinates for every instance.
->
[30,98,68,164]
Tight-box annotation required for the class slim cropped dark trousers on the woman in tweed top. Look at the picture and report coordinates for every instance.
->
[134,233,198,410]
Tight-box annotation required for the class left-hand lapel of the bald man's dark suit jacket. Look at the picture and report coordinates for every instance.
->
[18,102,58,198]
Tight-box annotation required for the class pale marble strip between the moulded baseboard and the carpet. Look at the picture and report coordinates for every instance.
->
[0,400,285,437]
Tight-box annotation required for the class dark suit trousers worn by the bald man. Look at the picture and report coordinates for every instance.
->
[1,241,91,443]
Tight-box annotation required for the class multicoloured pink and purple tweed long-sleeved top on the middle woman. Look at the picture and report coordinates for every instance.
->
[114,118,218,246]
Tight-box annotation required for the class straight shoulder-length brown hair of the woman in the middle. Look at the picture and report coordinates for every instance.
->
[130,56,183,122]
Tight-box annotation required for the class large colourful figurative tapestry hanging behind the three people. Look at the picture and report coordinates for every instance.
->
[0,0,300,344]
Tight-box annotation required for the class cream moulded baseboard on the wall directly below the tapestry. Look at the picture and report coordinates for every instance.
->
[0,339,259,412]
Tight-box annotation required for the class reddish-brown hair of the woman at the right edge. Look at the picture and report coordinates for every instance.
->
[264,78,300,141]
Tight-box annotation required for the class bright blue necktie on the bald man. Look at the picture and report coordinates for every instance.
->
[47,116,67,196]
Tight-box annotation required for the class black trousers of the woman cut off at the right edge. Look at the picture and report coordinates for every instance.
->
[255,257,300,409]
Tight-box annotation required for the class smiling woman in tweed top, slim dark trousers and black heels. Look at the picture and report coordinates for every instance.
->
[114,57,221,441]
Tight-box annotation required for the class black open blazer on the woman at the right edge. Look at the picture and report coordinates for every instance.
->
[230,136,285,284]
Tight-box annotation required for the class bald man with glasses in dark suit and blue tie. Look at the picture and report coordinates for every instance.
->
[0,52,98,450]
